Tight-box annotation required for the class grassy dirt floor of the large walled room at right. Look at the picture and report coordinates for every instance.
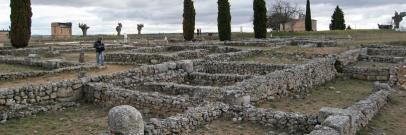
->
[258,79,373,113]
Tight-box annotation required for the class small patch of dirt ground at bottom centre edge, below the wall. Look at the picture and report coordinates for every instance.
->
[189,120,270,135]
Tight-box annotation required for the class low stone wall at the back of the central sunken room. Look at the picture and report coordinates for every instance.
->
[196,62,295,75]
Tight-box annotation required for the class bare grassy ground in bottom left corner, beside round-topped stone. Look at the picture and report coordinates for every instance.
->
[0,105,108,135]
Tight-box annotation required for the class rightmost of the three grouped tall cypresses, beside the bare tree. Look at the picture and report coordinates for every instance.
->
[253,0,267,38]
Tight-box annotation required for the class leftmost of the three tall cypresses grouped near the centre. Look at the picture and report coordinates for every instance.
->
[183,0,196,41]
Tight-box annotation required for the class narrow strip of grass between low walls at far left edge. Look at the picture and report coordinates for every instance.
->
[0,64,44,73]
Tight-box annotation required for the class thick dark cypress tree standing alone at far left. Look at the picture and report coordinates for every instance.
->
[9,0,32,48]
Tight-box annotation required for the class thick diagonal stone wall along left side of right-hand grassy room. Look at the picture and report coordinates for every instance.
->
[223,58,337,105]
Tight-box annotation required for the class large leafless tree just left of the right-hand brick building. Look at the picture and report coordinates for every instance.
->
[268,0,304,30]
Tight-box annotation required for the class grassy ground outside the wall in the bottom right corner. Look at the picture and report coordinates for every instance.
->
[358,91,406,135]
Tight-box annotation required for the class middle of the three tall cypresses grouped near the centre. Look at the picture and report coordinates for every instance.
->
[217,0,231,41]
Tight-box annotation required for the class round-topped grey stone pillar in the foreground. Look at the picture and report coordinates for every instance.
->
[108,105,144,135]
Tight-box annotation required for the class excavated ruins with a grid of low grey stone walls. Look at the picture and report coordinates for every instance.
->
[0,35,406,135]
